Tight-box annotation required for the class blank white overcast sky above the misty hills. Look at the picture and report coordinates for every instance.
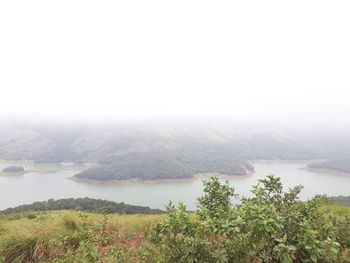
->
[0,0,350,124]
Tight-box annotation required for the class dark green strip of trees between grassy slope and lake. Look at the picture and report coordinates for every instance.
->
[0,197,163,214]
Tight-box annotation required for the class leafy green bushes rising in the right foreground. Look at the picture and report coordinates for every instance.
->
[153,175,349,263]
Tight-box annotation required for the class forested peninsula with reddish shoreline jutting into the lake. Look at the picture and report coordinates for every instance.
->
[75,153,254,180]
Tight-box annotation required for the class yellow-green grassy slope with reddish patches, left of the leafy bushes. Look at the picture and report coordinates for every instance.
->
[0,211,164,263]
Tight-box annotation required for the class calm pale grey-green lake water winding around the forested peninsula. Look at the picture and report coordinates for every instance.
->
[0,160,350,210]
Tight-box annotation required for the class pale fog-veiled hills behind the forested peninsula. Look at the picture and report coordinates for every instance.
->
[0,122,327,164]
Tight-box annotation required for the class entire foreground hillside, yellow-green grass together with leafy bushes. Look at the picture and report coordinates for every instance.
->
[0,176,350,263]
